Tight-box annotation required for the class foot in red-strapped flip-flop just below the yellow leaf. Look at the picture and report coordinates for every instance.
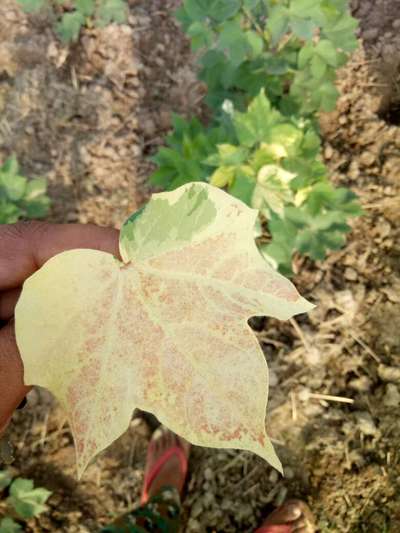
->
[146,428,190,498]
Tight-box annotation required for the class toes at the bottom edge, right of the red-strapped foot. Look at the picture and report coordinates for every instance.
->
[261,500,315,533]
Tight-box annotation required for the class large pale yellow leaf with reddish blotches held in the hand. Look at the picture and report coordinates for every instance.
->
[16,183,313,474]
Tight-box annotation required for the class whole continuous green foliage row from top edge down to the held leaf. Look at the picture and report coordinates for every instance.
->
[152,0,362,275]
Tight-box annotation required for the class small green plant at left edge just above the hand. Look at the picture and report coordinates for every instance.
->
[0,156,50,223]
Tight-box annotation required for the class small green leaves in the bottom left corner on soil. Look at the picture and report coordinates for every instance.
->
[0,470,51,533]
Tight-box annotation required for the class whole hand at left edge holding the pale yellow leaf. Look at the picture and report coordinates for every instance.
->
[0,222,119,436]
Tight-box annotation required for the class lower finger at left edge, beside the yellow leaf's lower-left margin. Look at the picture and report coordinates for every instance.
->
[0,323,30,434]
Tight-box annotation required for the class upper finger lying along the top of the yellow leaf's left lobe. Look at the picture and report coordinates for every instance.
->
[0,222,119,291]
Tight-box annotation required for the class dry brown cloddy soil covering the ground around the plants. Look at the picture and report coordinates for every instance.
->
[0,0,400,533]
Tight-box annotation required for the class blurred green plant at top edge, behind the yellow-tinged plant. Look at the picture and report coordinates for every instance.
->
[177,0,357,114]
